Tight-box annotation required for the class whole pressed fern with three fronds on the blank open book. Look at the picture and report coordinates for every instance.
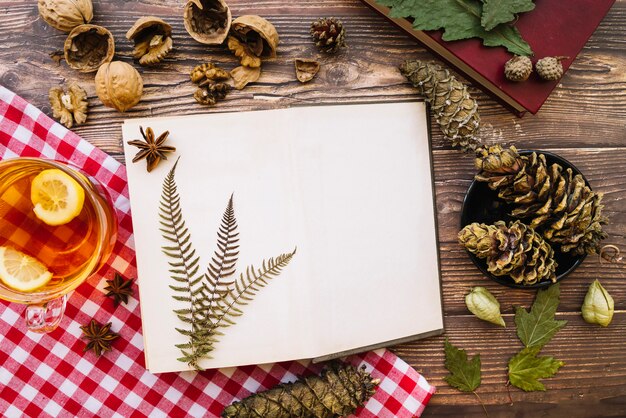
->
[159,160,296,370]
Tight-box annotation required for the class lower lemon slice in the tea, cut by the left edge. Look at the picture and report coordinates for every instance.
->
[0,247,52,292]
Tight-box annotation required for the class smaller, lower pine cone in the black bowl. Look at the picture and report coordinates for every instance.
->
[459,221,557,285]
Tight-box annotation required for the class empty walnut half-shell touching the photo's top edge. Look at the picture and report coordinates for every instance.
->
[183,0,232,45]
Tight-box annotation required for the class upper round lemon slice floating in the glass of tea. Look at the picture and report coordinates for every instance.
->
[30,168,85,225]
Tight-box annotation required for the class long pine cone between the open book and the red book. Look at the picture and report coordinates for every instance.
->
[400,61,480,151]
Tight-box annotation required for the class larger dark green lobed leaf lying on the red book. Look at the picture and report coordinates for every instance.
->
[378,0,533,55]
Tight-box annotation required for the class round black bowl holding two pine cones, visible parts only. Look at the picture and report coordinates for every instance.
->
[461,151,589,289]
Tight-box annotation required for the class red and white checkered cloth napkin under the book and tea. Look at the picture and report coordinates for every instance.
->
[0,86,435,417]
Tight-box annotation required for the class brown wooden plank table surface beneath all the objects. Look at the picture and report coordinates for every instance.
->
[0,0,626,418]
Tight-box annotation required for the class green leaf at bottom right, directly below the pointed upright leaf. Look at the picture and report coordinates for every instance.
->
[509,347,565,392]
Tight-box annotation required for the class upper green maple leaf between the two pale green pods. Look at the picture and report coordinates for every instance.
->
[515,283,567,349]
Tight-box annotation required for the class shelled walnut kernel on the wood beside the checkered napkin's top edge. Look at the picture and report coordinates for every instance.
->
[48,83,87,129]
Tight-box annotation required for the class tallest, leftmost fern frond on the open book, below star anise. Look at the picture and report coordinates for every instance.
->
[159,160,215,368]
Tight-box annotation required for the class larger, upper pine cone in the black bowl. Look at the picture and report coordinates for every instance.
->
[476,145,608,255]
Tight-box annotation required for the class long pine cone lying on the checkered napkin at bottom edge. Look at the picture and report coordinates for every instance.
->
[222,365,379,418]
